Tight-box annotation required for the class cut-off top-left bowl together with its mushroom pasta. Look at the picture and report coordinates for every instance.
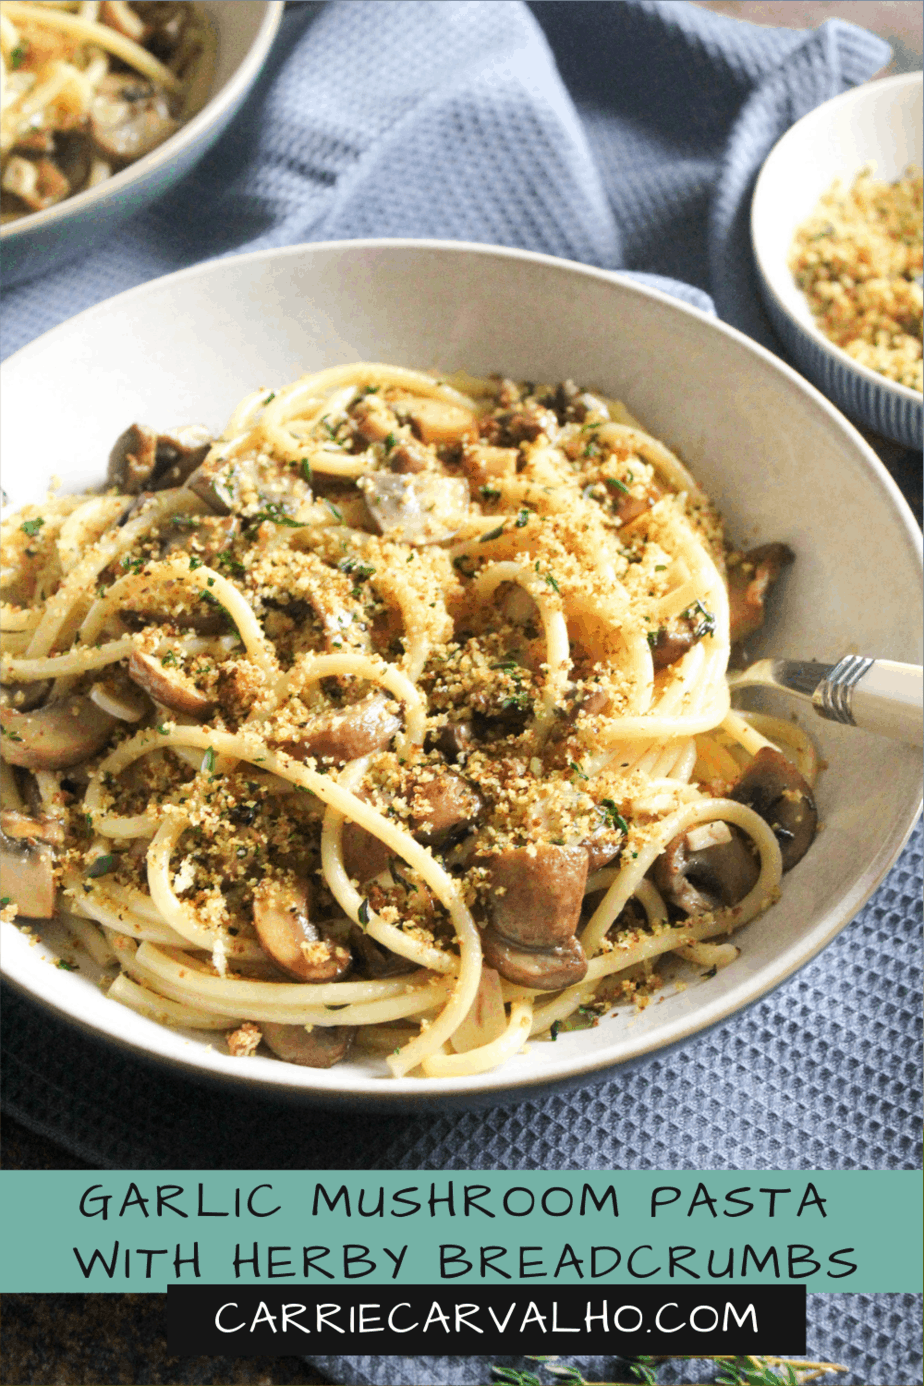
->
[0,0,283,284]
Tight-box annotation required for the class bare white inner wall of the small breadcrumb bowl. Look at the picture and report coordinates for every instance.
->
[751,73,924,398]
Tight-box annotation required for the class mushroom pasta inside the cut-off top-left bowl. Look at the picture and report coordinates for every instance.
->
[0,0,215,223]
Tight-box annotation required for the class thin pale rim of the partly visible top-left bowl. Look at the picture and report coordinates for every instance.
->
[0,0,285,243]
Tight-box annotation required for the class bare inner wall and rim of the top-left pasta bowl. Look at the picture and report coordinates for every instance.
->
[0,0,281,241]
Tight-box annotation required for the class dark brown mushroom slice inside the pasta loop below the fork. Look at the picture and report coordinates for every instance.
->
[652,823,761,915]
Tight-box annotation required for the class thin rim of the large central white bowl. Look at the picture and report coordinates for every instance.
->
[3,237,924,1110]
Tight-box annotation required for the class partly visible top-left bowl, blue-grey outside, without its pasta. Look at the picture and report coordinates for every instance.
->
[0,0,284,288]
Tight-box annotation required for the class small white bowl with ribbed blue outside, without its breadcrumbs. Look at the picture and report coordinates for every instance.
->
[751,72,924,448]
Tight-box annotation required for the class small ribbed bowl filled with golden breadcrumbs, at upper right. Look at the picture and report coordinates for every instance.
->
[751,73,924,448]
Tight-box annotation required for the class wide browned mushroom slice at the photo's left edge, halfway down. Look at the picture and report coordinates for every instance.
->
[0,693,116,771]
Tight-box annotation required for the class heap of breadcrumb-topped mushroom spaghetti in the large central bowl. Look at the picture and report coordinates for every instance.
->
[0,363,816,1078]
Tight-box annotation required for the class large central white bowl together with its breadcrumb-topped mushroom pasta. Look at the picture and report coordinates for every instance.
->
[0,241,921,1107]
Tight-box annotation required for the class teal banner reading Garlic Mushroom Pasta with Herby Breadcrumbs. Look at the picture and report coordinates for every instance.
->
[0,1170,923,1293]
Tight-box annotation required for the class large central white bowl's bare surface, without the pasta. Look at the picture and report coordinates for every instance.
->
[1,232,921,1106]
